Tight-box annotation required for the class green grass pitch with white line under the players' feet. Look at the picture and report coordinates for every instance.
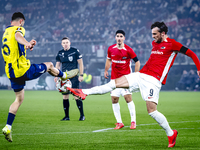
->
[0,90,200,150]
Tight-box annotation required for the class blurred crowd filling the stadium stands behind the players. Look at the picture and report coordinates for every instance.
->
[0,0,200,90]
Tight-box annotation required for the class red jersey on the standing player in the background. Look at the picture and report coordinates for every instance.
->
[107,44,137,79]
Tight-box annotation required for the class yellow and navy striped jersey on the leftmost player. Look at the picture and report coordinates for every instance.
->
[1,26,30,78]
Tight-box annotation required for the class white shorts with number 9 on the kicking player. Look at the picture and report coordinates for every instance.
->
[125,72,162,104]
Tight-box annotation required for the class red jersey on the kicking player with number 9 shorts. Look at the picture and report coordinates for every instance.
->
[140,38,183,84]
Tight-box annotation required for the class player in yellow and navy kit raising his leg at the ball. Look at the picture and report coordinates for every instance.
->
[1,12,78,142]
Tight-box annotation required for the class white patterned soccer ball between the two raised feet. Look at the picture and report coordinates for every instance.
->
[56,78,72,93]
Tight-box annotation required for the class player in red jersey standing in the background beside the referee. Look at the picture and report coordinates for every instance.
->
[104,30,140,129]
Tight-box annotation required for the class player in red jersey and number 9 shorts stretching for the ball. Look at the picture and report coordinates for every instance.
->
[64,22,200,147]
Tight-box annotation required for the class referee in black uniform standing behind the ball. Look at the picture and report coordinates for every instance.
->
[54,37,85,121]
